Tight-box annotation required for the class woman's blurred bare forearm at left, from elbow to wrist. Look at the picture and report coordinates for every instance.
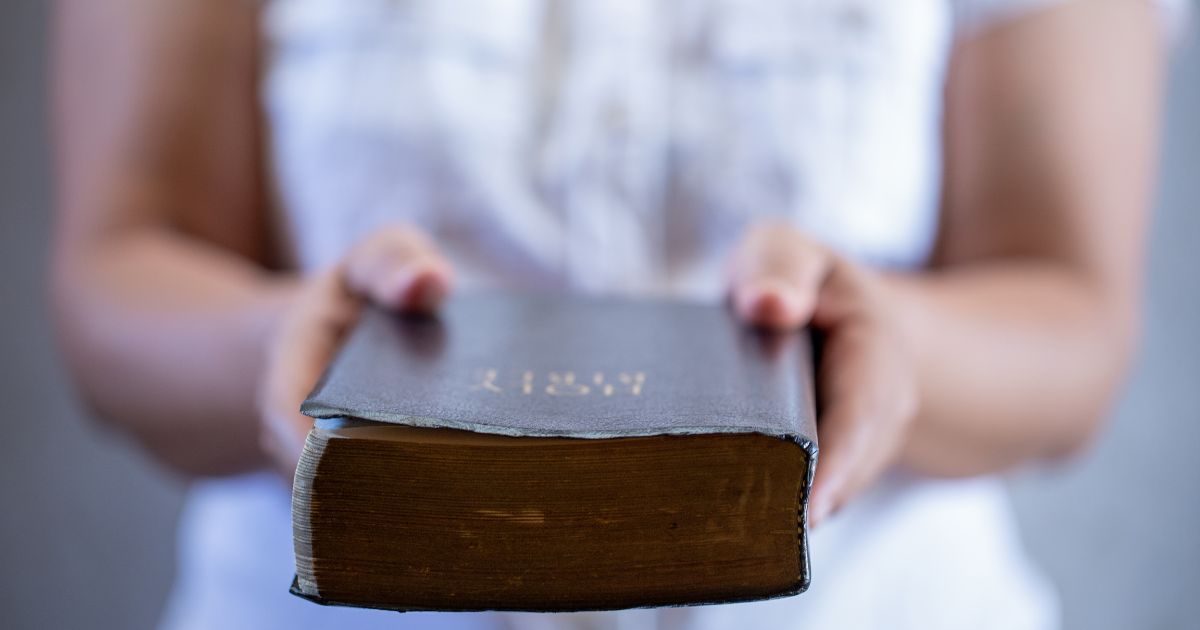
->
[53,227,294,474]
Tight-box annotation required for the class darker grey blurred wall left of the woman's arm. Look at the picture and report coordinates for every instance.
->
[0,0,184,629]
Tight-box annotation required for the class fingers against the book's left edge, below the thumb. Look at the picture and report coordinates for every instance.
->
[259,272,359,475]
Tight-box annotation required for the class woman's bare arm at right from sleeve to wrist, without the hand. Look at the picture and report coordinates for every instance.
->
[889,0,1163,475]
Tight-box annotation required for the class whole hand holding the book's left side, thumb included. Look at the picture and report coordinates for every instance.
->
[258,227,454,478]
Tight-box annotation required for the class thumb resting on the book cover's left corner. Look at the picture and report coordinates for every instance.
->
[343,228,454,312]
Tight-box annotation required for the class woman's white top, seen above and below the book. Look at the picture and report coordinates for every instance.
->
[164,0,1161,630]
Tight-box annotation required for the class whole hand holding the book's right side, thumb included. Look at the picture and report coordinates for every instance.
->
[730,223,917,524]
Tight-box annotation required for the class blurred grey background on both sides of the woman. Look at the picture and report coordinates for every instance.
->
[0,0,1200,630]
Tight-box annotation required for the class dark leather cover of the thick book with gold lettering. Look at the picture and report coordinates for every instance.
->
[300,294,817,610]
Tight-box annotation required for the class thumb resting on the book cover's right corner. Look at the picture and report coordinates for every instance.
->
[731,223,829,330]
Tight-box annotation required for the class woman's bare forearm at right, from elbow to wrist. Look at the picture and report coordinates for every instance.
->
[882,259,1136,476]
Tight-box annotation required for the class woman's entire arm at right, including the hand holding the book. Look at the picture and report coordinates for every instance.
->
[732,0,1162,520]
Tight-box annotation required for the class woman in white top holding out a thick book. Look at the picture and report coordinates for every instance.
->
[53,0,1180,629]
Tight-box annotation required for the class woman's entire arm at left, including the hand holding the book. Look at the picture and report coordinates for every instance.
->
[52,0,450,474]
